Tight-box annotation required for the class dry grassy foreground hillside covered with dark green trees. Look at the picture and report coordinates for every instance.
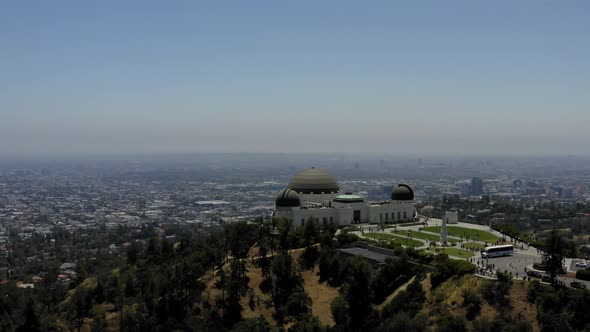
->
[0,220,590,332]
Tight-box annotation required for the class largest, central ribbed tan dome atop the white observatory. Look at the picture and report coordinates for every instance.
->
[288,167,340,194]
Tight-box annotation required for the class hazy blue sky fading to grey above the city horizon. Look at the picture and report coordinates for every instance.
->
[0,0,590,156]
